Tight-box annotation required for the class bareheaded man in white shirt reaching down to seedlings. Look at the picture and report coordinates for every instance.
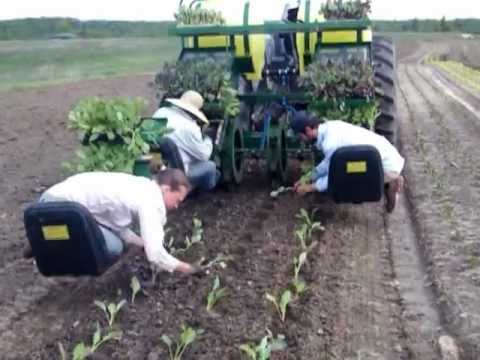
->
[25,169,201,274]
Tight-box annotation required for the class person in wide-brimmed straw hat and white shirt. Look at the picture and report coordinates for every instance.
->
[153,90,220,191]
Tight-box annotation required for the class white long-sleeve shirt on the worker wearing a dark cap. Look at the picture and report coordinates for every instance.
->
[312,120,405,192]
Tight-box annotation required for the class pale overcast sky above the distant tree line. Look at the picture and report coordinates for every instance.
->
[0,0,480,21]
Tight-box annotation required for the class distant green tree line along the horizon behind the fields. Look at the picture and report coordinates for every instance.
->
[0,18,480,40]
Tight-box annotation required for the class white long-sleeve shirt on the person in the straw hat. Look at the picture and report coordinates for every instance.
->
[153,107,213,174]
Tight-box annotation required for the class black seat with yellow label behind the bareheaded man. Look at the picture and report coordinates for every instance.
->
[24,201,118,276]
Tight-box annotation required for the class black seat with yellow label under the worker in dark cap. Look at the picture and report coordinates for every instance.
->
[328,145,384,204]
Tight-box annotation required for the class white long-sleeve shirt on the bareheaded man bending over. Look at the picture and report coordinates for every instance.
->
[46,172,180,272]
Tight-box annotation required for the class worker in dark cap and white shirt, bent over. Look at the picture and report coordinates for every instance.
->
[291,111,405,212]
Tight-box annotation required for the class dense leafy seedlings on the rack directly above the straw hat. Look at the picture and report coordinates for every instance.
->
[155,56,240,118]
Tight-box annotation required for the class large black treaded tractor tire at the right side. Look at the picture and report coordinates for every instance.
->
[372,36,397,144]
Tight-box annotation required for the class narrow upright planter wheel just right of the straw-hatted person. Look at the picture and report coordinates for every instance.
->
[221,119,243,184]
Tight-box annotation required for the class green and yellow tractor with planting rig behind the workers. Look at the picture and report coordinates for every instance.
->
[153,0,396,197]
